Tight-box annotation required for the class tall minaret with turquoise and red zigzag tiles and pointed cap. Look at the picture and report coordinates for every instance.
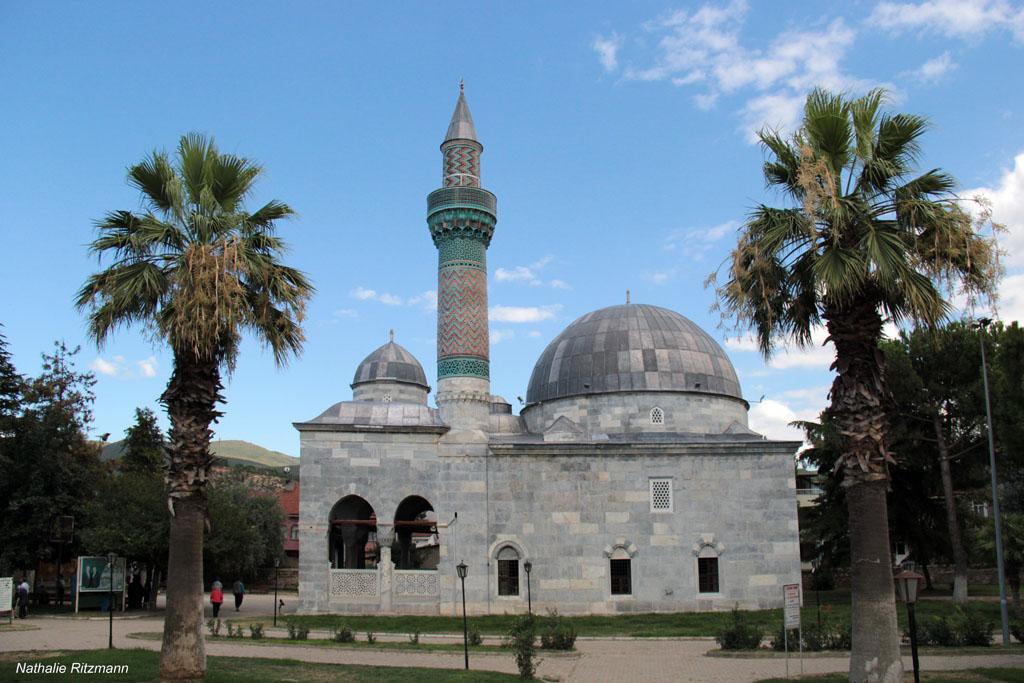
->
[427,83,498,431]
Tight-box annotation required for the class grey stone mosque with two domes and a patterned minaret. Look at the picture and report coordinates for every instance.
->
[295,92,800,614]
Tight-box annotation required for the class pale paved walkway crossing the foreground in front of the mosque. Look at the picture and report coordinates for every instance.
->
[0,610,1024,683]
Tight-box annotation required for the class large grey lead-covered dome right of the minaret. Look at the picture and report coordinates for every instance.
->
[526,304,742,403]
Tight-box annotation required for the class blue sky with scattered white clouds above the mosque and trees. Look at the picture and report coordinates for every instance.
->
[0,0,1024,455]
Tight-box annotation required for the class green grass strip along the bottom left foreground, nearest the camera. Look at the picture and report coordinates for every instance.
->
[0,650,520,683]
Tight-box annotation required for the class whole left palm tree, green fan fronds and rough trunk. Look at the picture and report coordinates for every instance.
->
[77,134,313,679]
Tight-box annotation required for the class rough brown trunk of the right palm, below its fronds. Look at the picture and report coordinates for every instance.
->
[824,301,903,683]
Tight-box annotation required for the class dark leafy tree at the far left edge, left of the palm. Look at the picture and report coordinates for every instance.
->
[0,342,100,568]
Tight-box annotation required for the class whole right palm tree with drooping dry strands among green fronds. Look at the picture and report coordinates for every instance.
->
[718,89,997,681]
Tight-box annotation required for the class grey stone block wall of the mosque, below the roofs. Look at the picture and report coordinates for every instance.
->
[299,431,800,613]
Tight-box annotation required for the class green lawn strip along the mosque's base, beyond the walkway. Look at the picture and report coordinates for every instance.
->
[268,590,999,638]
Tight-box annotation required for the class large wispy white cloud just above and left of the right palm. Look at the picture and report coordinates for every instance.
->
[602,0,870,142]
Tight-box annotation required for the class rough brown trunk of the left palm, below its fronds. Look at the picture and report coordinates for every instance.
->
[160,350,221,680]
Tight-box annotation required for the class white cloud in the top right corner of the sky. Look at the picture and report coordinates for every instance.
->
[867,0,1024,40]
